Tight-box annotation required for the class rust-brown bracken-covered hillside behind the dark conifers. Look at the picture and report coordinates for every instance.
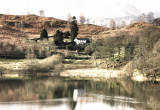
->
[0,15,108,41]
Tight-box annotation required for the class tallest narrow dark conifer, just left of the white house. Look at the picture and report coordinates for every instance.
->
[70,16,79,43]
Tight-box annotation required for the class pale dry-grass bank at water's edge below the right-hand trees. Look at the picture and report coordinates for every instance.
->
[60,68,160,82]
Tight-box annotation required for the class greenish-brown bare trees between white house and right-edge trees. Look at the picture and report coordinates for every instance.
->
[85,32,137,69]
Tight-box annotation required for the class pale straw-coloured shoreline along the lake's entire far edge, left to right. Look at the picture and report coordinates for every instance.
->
[0,68,160,82]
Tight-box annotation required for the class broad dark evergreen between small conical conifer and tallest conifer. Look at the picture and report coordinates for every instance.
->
[54,30,63,45]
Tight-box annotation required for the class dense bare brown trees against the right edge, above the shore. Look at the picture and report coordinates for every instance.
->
[135,26,160,75]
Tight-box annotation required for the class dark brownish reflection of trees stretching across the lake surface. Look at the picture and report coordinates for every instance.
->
[0,78,160,110]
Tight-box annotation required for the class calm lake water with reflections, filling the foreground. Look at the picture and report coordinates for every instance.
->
[0,77,160,110]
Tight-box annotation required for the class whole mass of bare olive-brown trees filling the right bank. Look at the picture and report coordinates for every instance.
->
[85,26,160,77]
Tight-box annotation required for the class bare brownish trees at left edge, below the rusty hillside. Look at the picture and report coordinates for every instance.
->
[0,40,55,59]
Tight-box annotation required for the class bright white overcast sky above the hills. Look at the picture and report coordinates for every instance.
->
[0,0,160,19]
